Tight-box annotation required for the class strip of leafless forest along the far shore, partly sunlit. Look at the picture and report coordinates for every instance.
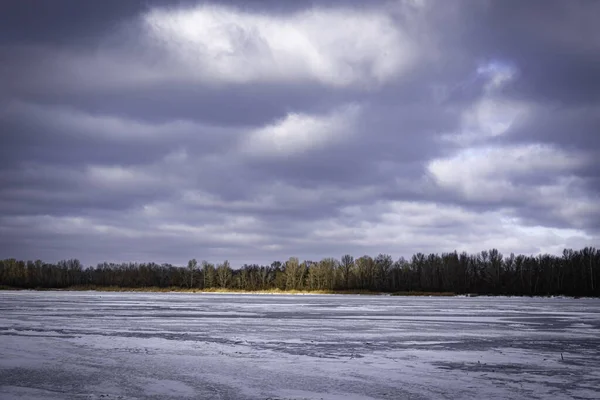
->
[0,247,600,296]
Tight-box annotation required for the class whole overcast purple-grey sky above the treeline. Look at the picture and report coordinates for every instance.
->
[0,0,600,266]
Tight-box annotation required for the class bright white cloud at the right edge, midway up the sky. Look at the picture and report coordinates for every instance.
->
[427,144,600,229]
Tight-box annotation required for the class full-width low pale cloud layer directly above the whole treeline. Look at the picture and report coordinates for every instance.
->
[0,192,598,266]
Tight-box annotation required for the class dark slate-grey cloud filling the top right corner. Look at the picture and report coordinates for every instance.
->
[472,0,600,105]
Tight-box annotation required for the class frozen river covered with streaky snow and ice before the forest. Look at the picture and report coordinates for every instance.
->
[0,292,600,400]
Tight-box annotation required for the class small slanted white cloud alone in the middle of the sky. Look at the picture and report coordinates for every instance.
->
[240,105,359,157]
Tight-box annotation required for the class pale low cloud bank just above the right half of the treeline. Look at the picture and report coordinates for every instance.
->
[308,201,597,255]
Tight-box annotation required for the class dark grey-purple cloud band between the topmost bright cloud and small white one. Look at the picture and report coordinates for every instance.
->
[27,84,356,127]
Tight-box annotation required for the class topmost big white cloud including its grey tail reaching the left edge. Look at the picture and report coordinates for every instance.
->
[0,3,420,95]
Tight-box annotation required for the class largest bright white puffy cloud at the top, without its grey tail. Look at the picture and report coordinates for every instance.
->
[143,4,417,86]
